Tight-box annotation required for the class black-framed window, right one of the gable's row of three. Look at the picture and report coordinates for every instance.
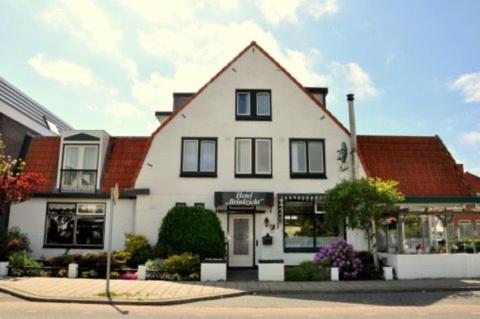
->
[290,139,327,178]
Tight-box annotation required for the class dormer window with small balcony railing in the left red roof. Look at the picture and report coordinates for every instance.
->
[60,144,98,192]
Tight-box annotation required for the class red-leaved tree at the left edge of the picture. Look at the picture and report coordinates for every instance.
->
[0,138,44,205]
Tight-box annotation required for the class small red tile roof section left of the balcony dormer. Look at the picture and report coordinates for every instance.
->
[25,137,60,193]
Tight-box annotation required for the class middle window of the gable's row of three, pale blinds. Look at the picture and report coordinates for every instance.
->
[235,138,272,178]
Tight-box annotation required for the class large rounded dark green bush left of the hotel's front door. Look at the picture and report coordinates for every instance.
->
[156,206,225,259]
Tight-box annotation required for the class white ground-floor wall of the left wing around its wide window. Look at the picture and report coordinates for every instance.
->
[9,198,135,258]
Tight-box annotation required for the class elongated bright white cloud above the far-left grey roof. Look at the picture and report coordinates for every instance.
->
[28,53,93,87]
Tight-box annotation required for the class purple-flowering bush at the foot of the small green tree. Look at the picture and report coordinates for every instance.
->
[313,239,362,279]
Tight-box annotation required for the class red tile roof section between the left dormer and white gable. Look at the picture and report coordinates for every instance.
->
[102,137,150,193]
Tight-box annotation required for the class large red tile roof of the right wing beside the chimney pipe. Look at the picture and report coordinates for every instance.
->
[358,136,473,196]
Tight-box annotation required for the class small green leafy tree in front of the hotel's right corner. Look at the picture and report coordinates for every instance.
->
[325,178,404,268]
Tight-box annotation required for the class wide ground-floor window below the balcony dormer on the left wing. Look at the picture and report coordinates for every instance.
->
[44,203,105,248]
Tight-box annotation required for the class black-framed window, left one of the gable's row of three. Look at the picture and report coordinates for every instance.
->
[180,137,217,177]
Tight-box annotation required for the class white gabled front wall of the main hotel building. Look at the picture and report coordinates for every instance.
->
[135,45,362,264]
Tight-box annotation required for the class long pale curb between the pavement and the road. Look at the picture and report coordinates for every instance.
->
[0,286,480,306]
